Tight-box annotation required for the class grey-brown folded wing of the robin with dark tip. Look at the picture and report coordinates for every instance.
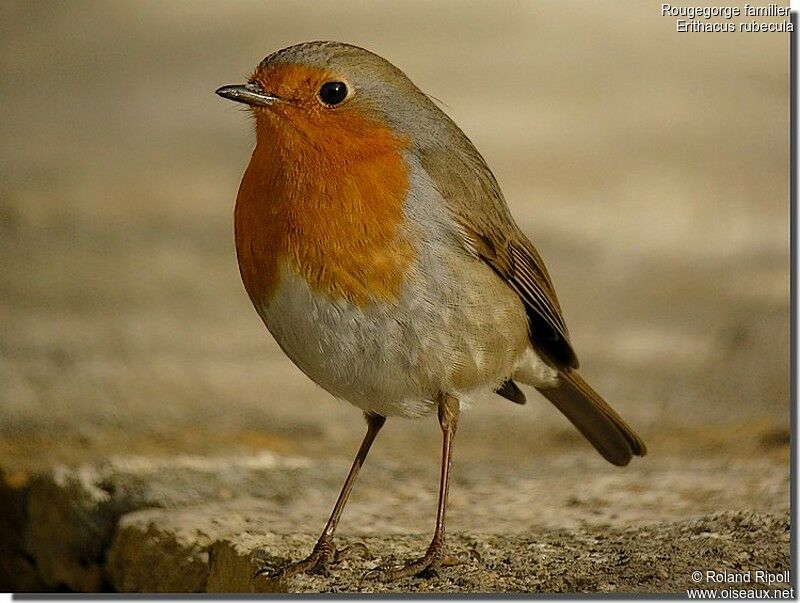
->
[420,144,578,369]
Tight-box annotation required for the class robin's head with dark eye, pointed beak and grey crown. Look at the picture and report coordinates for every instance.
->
[216,42,442,158]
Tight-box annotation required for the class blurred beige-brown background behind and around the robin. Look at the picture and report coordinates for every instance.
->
[0,0,789,530]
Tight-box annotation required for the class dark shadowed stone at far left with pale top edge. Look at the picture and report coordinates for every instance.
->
[11,452,307,591]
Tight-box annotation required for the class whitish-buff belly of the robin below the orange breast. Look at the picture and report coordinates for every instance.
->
[256,252,552,417]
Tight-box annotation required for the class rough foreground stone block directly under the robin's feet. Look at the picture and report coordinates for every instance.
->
[104,503,789,593]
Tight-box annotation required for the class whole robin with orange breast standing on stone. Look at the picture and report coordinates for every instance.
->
[216,41,647,581]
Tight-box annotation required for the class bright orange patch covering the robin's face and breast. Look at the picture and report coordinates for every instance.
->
[235,66,414,305]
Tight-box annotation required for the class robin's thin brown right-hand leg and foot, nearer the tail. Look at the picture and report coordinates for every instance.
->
[366,394,459,582]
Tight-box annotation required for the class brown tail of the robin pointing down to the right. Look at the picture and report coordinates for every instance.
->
[537,371,647,466]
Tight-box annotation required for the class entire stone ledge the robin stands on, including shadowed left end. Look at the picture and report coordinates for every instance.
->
[0,452,788,592]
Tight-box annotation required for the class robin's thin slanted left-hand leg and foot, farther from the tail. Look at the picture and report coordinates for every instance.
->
[256,413,386,580]
